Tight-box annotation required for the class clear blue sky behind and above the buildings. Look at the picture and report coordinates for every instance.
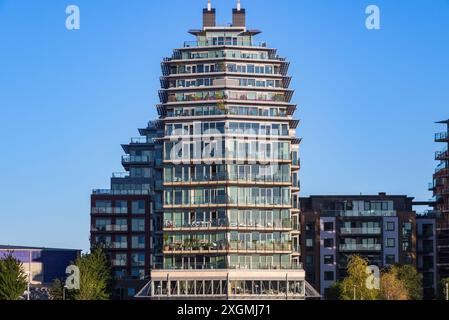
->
[0,0,449,249]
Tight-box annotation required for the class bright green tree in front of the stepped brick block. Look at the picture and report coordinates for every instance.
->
[74,247,112,300]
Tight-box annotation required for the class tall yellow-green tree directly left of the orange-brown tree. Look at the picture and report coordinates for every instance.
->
[340,255,379,300]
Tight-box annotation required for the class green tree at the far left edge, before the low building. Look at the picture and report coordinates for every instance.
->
[0,252,28,300]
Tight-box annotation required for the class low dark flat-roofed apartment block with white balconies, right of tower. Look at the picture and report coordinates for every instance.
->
[301,193,416,296]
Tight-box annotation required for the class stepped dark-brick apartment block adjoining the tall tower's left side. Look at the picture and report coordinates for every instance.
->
[91,121,163,299]
